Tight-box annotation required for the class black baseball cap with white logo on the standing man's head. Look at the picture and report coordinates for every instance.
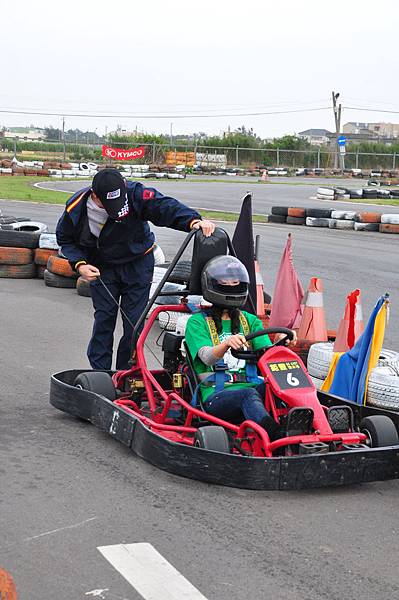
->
[91,169,129,219]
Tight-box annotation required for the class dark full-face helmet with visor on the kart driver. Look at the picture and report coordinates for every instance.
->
[201,255,249,308]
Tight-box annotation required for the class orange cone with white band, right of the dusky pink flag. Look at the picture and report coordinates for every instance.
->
[297,277,328,342]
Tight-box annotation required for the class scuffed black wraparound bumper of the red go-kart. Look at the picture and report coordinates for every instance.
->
[50,370,399,490]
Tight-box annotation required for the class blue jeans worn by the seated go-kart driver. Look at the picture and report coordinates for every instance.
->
[204,383,270,424]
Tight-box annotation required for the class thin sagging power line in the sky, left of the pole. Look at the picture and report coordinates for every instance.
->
[0,106,331,119]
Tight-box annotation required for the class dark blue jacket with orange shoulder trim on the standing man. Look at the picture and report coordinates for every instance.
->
[56,181,201,268]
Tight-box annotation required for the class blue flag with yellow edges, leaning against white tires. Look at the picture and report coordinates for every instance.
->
[321,294,389,404]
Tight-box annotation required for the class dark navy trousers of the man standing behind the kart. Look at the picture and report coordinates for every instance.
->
[87,252,154,370]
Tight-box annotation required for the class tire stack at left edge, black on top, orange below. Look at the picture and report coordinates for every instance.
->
[0,229,39,279]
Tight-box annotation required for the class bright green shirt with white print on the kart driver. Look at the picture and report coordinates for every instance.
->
[185,311,272,402]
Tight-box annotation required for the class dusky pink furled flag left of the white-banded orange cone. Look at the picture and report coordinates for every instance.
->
[269,233,304,329]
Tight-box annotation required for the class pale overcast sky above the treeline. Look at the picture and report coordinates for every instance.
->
[0,0,399,137]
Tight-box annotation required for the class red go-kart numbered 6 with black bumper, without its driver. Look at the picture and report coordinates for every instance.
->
[50,227,399,489]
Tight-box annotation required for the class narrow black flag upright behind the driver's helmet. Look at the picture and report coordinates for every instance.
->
[232,192,256,315]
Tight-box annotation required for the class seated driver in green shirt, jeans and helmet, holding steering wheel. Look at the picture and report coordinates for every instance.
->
[185,256,295,441]
